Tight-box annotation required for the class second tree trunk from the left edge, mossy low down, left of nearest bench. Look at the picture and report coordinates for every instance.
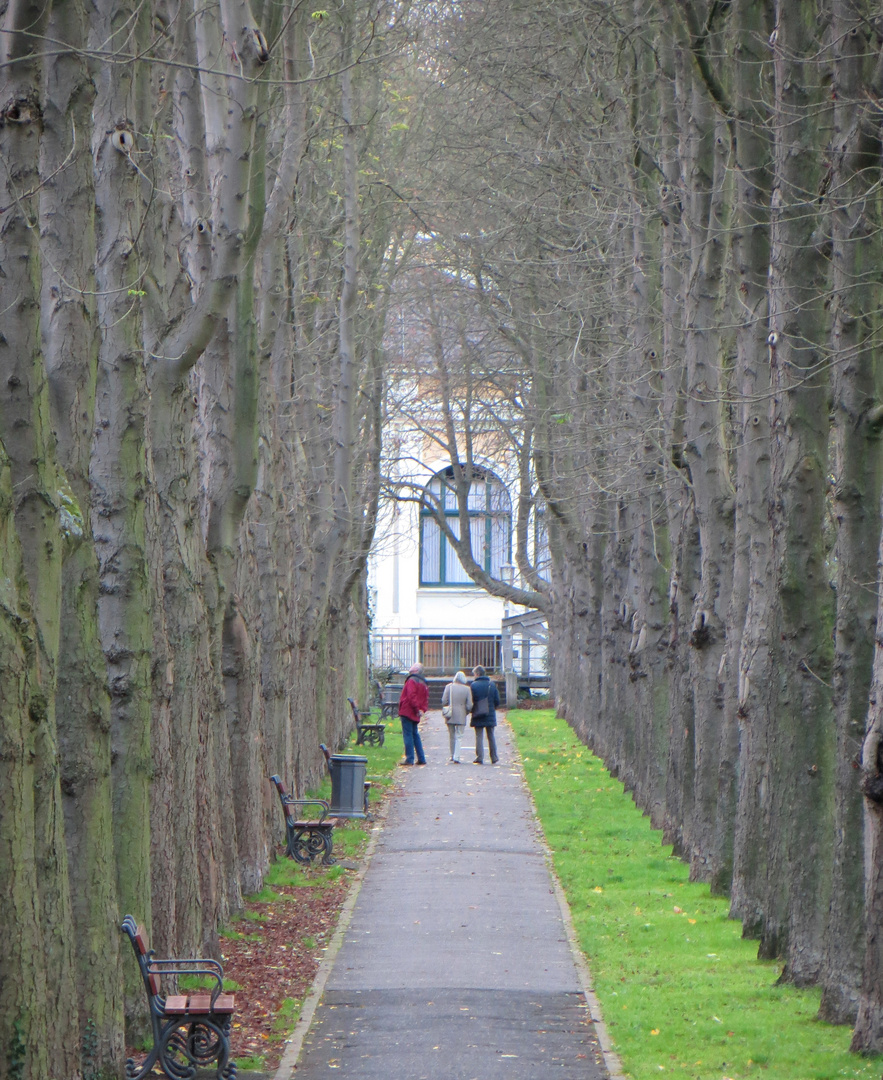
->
[40,2,124,1071]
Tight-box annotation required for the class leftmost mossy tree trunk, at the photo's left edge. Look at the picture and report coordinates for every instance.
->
[0,2,80,1080]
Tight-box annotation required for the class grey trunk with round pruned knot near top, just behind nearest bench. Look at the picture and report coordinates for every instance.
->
[89,2,162,1017]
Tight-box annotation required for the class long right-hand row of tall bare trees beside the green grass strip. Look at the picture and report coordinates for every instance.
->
[384,0,883,1051]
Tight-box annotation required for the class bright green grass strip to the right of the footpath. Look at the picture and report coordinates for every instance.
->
[508,710,881,1080]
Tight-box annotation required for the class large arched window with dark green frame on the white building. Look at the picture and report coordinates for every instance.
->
[420,469,512,585]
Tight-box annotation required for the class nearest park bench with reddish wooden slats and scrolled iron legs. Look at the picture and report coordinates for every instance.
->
[121,915,236,1080]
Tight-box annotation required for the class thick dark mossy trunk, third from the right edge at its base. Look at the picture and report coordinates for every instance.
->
[761,2,834,985]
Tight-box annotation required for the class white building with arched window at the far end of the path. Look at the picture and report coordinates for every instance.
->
[368,267,547,679]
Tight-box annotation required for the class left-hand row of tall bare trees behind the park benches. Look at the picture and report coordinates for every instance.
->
[0,0,400,1080]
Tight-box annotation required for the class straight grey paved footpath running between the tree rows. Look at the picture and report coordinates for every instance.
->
[277,712,609,1080]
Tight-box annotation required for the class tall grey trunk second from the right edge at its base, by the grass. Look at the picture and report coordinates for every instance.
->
[819,0,882,1023]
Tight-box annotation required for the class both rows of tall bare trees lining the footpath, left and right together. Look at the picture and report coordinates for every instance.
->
[8,0,883,1080]
